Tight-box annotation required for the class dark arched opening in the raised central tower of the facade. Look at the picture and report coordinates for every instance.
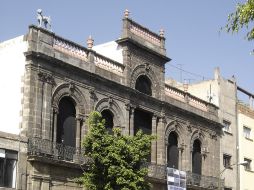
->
[135,75,152,96]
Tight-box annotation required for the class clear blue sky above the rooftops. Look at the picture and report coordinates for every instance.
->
[0,0,254,99]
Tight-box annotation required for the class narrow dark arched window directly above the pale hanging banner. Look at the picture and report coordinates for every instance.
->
[167,132,179,169]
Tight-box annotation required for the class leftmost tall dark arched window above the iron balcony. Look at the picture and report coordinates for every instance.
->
[56,97,76,147]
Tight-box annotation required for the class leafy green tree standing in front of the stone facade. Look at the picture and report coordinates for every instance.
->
[79,111,154,190]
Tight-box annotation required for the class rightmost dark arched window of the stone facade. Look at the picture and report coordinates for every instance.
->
[192,139,202,175]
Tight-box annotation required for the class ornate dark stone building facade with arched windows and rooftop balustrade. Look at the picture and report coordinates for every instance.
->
[0,14,223,190]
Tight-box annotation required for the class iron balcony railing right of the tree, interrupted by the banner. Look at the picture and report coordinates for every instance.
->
[146,163,224,189]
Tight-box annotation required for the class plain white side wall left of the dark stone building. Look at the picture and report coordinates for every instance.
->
[0,36,28,134]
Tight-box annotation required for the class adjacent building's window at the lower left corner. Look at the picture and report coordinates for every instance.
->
[0,149,18,188]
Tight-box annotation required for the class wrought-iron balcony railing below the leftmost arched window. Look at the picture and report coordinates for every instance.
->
[27,138,85,164]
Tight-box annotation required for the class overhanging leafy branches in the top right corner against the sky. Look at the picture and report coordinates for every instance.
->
[225,0,254,40]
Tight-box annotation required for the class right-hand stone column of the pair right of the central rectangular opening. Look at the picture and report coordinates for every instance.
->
[157,116,166,164]
